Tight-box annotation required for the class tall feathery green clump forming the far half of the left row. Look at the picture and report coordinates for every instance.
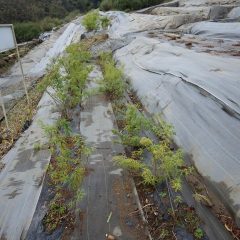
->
[40,44,92,117]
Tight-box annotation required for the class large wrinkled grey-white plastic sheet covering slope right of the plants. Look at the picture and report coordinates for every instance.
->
[115,37,240,224]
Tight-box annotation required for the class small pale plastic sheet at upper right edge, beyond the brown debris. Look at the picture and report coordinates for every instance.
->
[186,22,240,40]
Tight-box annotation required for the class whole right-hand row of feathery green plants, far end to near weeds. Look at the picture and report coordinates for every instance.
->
[99,52,201,239]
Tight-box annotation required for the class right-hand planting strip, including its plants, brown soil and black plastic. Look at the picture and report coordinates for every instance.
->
[99,53,238,239]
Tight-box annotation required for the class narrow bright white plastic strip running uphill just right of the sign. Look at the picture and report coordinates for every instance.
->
[29,23,80,77]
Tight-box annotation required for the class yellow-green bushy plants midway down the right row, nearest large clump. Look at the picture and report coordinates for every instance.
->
[115,105,186,191]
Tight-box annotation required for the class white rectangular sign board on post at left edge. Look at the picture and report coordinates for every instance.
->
[0,24,16,52]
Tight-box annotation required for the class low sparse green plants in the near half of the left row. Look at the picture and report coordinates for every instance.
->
[42,119,90,232]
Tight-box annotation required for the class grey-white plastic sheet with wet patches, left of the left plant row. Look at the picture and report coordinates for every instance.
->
[0,88,60,240]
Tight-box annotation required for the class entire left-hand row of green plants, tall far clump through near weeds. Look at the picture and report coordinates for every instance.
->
[40,44,92,232]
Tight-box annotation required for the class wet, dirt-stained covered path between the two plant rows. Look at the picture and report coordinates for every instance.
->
[72,67,147,240]
